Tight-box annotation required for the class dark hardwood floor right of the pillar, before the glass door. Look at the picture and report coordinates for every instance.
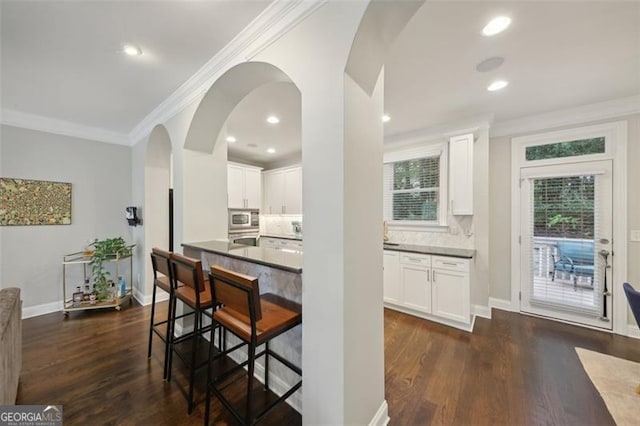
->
[385,309,640,425]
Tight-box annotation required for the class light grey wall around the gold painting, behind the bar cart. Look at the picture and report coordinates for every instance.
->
[0,126,132,315]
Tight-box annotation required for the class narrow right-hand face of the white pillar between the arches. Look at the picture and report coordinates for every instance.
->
[344,72,385,424]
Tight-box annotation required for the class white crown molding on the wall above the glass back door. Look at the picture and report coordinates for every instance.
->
[491,95,640,138]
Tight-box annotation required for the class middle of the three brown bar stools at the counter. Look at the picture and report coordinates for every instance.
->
[167,253,214,414]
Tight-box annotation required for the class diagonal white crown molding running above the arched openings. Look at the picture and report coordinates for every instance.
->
[129,0,328,144]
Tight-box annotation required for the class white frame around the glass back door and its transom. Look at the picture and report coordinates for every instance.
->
[511,121,629,336]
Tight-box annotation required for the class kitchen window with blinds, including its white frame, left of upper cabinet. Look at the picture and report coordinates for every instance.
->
[384,145,447,226]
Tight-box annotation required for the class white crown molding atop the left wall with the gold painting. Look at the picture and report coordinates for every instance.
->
[1,109,130,146]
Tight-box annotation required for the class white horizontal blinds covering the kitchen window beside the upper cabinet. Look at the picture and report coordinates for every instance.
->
[384,155,440,223]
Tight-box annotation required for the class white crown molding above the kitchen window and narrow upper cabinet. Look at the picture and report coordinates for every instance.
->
[384,114,493,147]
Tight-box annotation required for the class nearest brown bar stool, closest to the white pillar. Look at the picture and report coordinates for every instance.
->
[205,265,302,425]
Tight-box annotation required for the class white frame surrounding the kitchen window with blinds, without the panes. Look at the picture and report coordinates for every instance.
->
[383,142,449,232]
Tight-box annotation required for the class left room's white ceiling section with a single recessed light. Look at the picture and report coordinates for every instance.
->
[0,0,269,134]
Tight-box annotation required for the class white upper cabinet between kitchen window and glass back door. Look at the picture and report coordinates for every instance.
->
[449,133,473,215]
